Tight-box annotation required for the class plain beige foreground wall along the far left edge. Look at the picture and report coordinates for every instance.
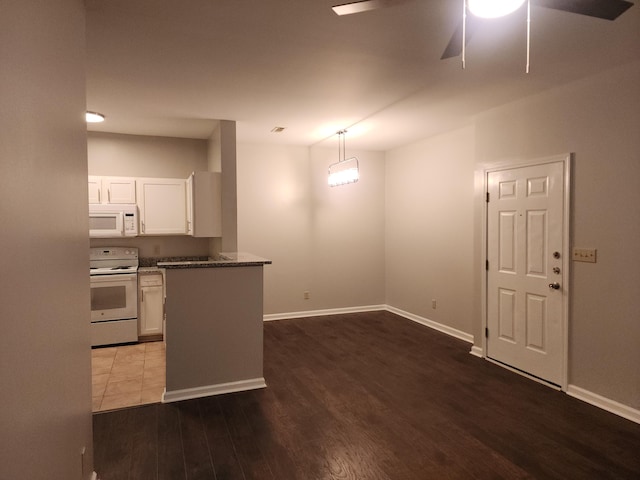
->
[0,0,93,480]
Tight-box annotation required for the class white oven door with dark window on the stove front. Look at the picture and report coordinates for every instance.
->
[91,273,138,322]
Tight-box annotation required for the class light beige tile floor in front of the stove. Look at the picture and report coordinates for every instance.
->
[91,342,166,412]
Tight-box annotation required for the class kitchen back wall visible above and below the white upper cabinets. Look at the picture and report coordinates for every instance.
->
[87,132,210,257]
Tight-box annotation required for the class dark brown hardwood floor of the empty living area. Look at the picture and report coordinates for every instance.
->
[94,312,640,480]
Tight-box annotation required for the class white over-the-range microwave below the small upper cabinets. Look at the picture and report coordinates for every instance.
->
[89,204,138,238]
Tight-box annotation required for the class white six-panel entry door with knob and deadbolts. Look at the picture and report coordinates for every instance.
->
[486,162,568,385]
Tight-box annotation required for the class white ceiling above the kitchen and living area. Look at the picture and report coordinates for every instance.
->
[86,0,640,150]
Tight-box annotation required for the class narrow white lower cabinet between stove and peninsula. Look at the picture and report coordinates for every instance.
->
[138,272,164,339]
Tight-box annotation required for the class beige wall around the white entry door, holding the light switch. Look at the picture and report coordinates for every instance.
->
[476,62,640,409]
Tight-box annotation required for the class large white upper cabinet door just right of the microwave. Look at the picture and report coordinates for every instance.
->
[137,178,187,235]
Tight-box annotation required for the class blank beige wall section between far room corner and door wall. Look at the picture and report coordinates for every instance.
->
[385,127,477,333]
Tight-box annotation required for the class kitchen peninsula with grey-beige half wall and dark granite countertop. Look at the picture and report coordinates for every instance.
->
[158,253,271,402]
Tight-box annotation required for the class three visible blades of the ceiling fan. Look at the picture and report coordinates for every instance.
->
[331,0,633,60]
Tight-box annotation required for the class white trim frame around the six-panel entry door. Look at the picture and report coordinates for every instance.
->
[480,153,573,392]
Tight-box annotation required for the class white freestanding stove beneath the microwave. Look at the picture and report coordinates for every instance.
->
[89,247,138,346]
